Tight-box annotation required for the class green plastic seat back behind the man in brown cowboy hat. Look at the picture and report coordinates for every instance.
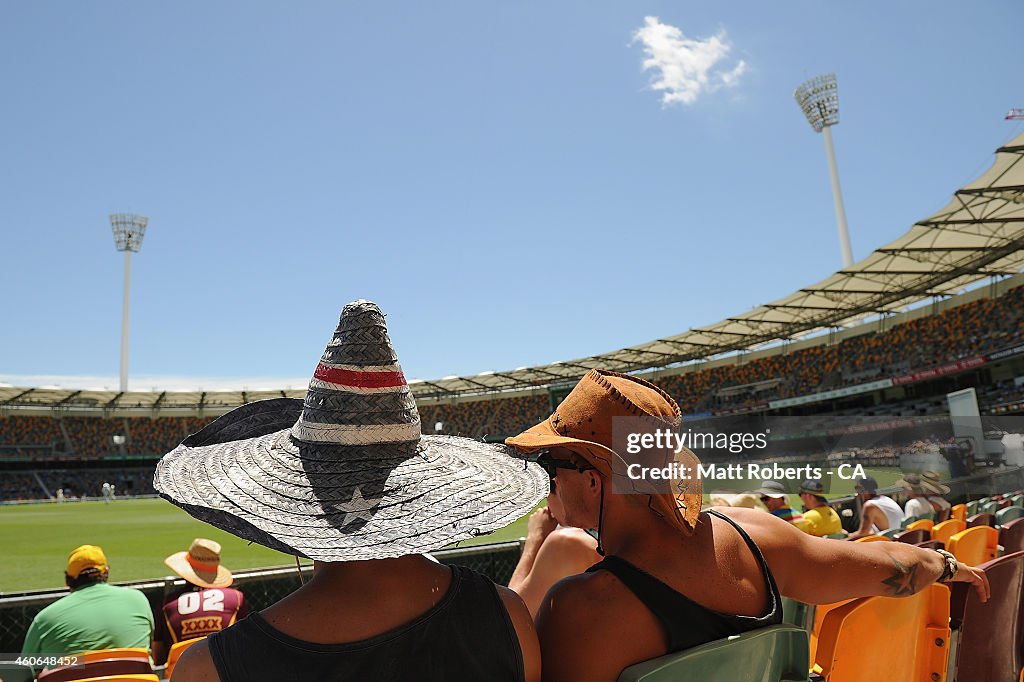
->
[618,625,810,682]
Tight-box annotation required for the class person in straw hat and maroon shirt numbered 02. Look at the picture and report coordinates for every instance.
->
[153,538,249,664]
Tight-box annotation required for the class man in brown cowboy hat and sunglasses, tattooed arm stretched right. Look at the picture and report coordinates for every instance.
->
[506,370,988,682]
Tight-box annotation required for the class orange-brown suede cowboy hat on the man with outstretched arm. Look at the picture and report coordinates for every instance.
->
[505,370,701,535]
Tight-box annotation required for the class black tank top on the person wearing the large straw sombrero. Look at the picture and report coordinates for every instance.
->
[209,566,523,682]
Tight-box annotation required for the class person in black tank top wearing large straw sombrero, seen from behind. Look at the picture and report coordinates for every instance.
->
[154,301,548,682]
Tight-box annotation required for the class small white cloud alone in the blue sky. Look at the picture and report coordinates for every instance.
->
[633,16,746,105]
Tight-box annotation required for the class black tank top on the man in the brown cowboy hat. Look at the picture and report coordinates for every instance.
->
[587,510,782,653]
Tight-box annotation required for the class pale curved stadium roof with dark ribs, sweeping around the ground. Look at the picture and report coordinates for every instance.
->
[6,134,1024,410]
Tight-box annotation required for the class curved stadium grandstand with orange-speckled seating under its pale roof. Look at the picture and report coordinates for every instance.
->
[0,135,1024,501]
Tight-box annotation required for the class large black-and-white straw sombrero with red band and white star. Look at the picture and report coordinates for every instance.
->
[154,300,548,561]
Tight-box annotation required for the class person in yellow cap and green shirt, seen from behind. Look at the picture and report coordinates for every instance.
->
[22,545,153,655]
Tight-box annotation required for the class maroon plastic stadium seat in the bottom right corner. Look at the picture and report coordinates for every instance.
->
[950,552,1024,682]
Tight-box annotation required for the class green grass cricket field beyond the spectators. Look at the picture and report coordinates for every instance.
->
[0,469,900,593]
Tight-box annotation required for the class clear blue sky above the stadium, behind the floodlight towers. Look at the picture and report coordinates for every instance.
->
[0,1,1024,389]
